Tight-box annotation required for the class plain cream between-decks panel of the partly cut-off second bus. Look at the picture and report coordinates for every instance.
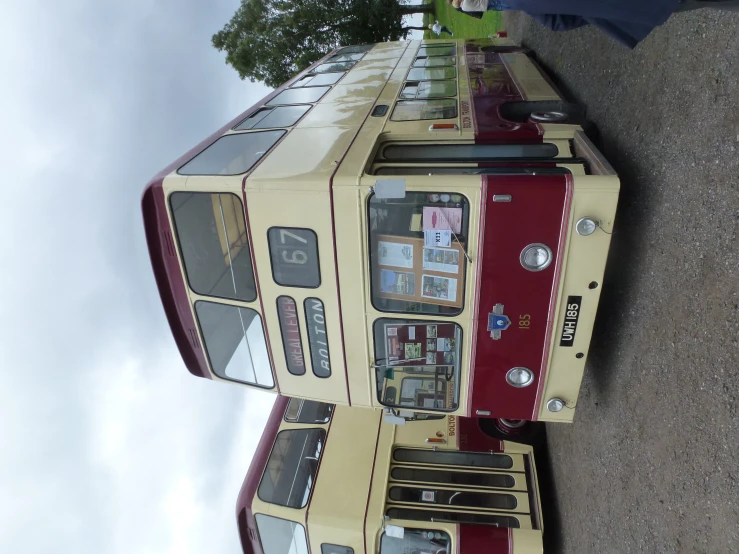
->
[308,406,387,554]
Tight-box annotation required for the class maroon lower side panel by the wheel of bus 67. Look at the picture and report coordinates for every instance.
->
[466,50,542,143]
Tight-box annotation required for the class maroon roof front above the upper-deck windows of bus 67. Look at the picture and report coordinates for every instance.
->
[141,183,211,379]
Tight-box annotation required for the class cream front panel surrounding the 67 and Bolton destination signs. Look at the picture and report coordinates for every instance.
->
[241,185,349,403]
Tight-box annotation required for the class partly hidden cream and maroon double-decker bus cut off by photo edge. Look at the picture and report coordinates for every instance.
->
[236,397,543,554]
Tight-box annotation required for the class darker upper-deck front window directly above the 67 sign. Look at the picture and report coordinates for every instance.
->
[169,192,257,302]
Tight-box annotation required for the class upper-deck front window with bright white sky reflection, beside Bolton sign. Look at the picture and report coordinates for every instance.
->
[195,301,274,388]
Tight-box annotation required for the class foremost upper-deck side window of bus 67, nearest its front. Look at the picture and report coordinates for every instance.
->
[177,131,285,175]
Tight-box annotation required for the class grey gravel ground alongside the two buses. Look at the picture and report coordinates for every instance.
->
[503,8,739,554]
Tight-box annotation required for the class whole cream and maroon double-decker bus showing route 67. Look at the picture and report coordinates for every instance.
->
[142,39,619,434]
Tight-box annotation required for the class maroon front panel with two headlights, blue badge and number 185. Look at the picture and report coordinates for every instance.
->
[471,175,567,420]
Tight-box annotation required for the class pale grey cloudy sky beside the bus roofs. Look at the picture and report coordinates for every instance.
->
[0,0,422,554]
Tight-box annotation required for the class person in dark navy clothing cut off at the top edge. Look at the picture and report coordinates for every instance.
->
[447,0,739,48]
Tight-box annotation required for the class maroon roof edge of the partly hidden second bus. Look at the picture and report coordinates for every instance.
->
[236,396,290,554]
